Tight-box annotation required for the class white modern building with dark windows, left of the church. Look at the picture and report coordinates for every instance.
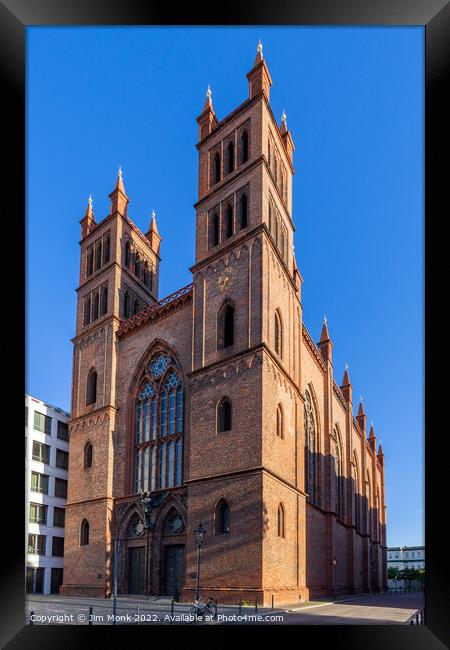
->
[25,395,70,594]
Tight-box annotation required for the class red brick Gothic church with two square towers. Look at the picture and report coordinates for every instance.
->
[61,45,386,604]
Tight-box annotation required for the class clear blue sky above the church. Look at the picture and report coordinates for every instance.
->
[26,26,424,545]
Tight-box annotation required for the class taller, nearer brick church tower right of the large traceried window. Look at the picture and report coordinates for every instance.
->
[186,43,305,602]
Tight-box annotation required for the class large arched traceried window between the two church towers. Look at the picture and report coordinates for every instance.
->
[134,351,184,493]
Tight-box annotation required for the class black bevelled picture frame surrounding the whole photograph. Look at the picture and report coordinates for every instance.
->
[5,0,450,650]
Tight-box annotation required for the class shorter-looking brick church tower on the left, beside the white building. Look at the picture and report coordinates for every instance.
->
[61,169,161,595]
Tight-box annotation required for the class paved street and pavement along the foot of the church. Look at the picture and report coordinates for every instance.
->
[25,593,424,625]
